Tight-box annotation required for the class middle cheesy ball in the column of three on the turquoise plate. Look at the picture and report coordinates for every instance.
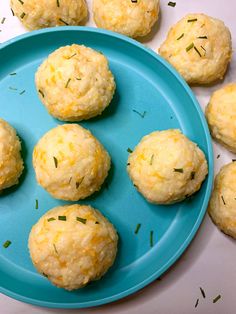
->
[33,124,111,201]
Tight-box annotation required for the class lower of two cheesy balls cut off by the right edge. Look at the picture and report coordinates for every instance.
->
[208,162,236,239]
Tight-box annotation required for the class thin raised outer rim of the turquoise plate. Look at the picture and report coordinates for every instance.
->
[0,26,214,309]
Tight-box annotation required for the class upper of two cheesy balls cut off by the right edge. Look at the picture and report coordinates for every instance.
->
[206,83,236,153]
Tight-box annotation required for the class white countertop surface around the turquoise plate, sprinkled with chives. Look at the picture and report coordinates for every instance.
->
[0,0,236,314]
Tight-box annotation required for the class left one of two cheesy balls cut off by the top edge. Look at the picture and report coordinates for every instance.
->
[10,0,88,30]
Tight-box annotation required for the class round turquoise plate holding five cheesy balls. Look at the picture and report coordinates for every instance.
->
[0,27,213,308]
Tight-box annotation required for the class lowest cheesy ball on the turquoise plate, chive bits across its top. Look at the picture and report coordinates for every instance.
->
[28,204,118,290]
